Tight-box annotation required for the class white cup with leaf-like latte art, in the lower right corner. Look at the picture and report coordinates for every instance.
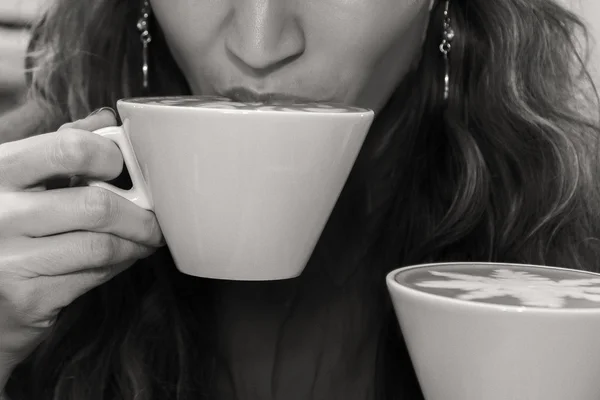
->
[387,262,600,400]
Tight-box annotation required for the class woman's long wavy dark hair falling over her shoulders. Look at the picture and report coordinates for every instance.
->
[7,0,600,400]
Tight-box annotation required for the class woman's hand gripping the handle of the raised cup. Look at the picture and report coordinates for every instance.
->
[0,111,163,365]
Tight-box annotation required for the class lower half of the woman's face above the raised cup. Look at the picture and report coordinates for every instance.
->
[151,0,435,110]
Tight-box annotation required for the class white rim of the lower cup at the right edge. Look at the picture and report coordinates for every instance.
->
[386,261,600,315]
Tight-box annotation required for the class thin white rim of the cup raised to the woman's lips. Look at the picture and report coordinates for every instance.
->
[117,95,375,118]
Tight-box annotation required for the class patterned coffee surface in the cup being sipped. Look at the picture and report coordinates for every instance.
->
[126,96,368,114]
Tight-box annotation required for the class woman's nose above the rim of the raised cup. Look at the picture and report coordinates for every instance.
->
[225,0,305,75]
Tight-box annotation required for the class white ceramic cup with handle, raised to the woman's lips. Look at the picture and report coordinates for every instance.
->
[90,96,374,280]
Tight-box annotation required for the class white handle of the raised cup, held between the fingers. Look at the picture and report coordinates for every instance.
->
[87,126,154,210]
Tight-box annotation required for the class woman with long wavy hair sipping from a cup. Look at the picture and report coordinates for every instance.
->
[0,0,600,400]
